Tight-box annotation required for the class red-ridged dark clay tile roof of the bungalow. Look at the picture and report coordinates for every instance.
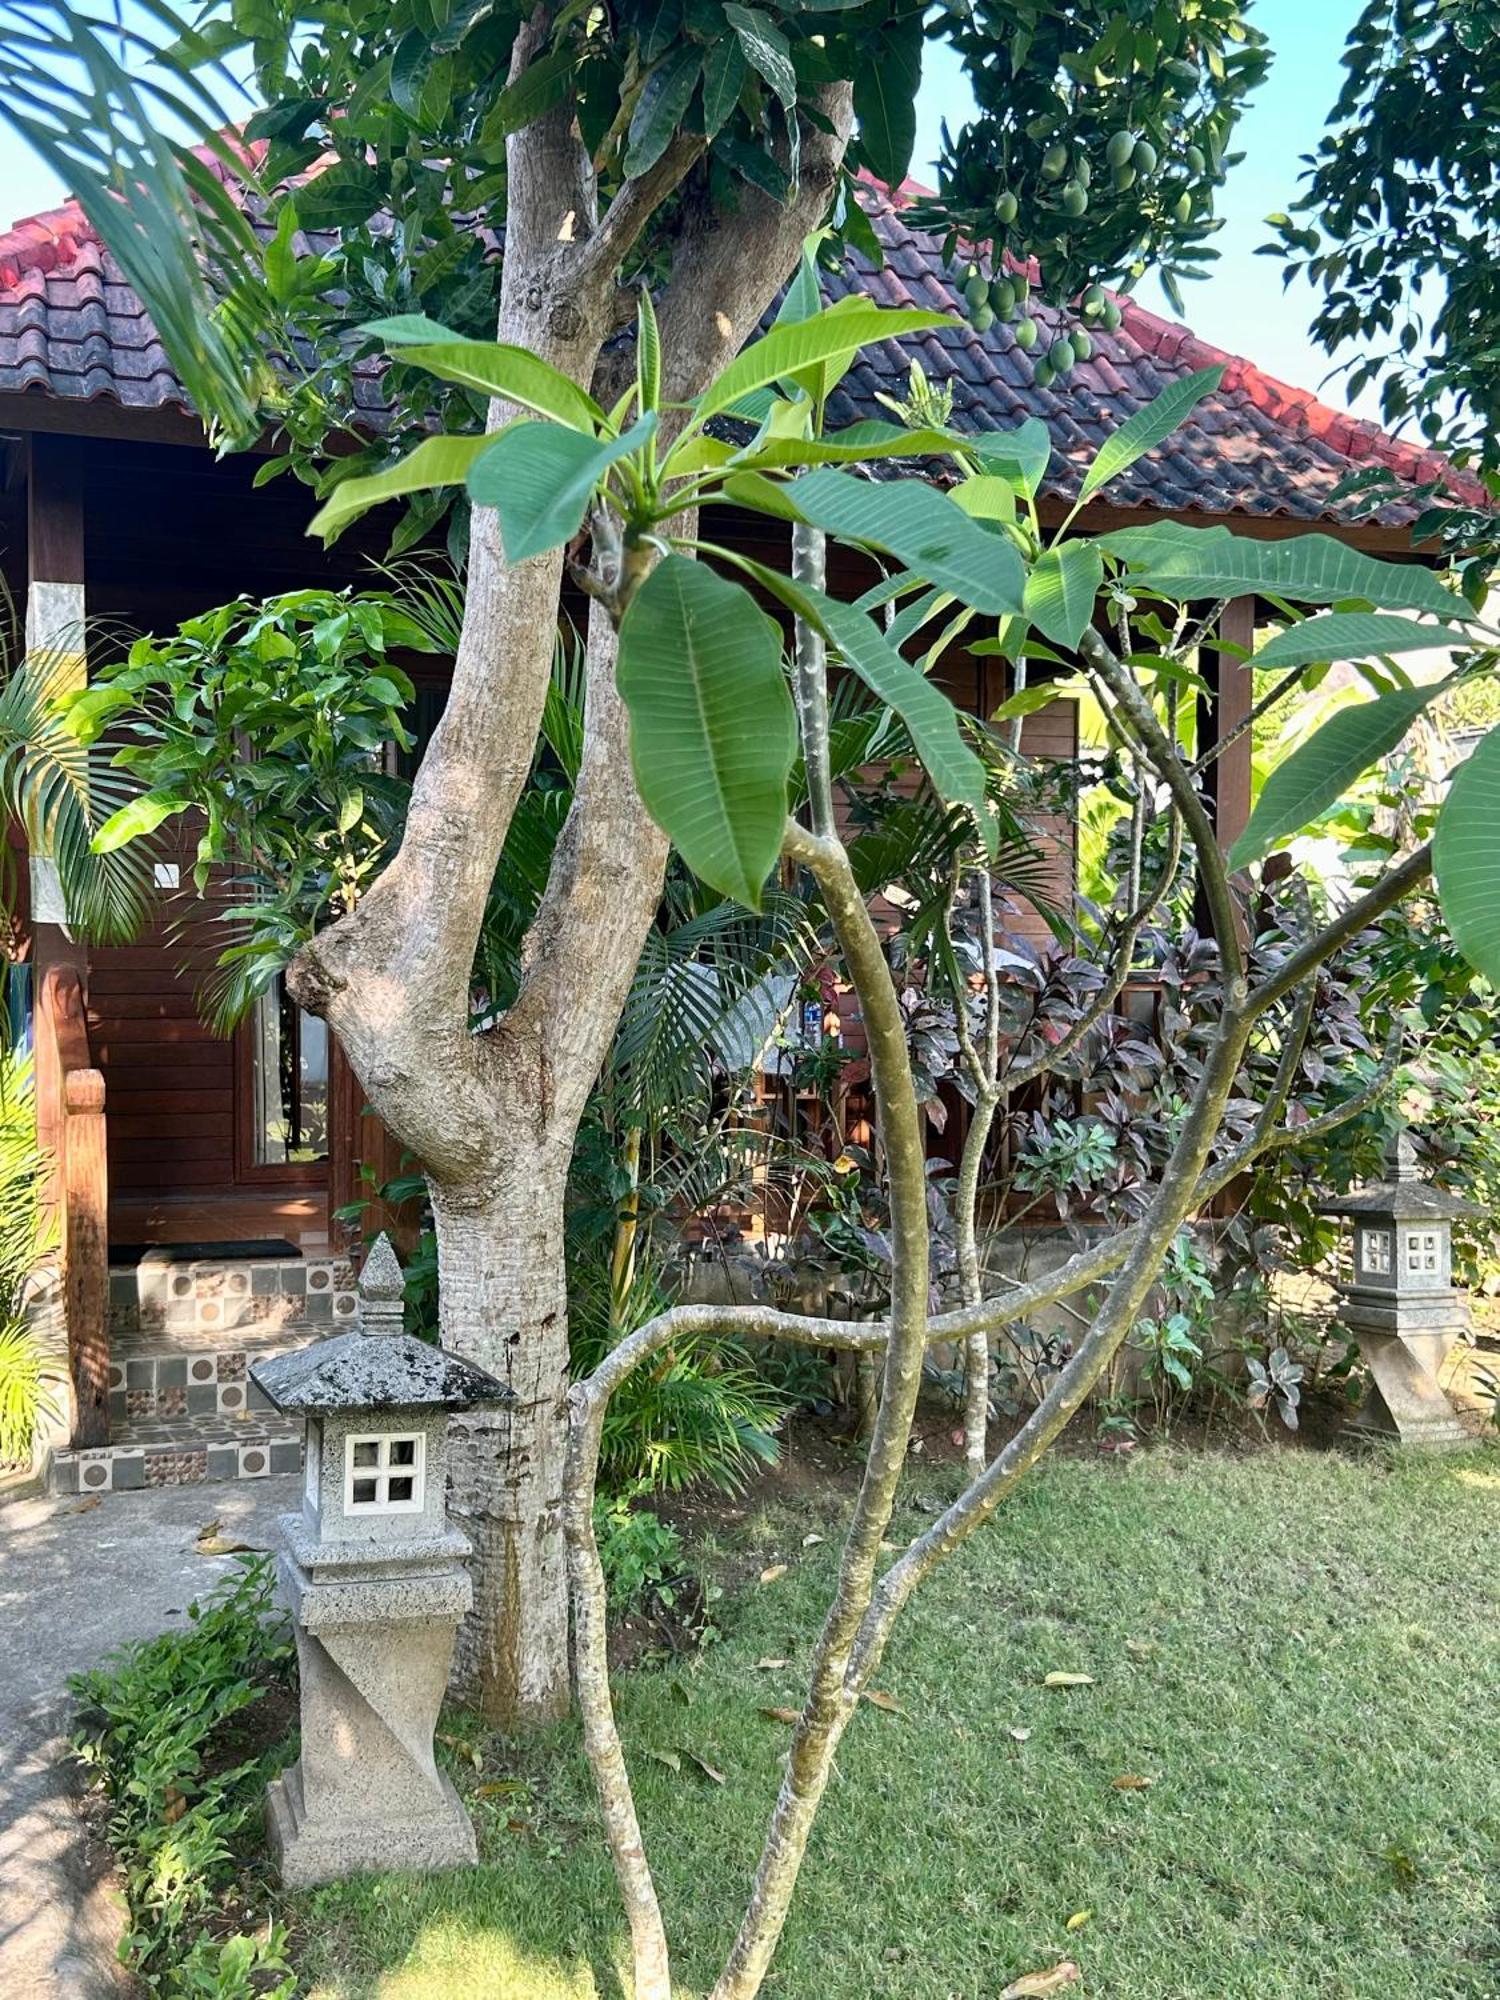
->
[0,188,1484,526]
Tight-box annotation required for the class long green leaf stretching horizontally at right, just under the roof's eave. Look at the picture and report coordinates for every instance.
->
[1098,520,1464,618]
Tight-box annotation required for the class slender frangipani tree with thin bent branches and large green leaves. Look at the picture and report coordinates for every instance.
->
[308,294,1500,2000]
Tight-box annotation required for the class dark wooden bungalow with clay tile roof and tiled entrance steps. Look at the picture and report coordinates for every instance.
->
[0,190,1472,1486]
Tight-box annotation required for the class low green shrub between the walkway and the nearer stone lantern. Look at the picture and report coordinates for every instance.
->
[70,1556,294,2000]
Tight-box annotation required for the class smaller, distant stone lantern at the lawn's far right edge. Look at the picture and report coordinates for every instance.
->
[1322,1132,1478,1444]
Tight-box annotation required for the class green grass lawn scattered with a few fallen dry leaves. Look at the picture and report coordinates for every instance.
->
[288,1450,1500,2000]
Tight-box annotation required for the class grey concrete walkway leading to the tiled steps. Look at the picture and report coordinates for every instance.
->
[0,1476,300,2000]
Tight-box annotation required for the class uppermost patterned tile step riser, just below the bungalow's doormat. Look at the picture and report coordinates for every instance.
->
[110,1258,356,1350]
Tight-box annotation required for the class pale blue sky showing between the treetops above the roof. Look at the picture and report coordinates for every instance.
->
[0,0,1374,416]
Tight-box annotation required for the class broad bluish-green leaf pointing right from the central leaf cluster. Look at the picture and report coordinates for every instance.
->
[792,468,1026,616]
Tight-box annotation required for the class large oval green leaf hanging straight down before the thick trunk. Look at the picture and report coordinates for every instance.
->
[616,556,796,910]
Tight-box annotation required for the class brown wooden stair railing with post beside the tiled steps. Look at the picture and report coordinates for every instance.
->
[34,964,110,1446]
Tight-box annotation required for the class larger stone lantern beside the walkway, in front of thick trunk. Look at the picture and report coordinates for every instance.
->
[250,1236,512,1888]
